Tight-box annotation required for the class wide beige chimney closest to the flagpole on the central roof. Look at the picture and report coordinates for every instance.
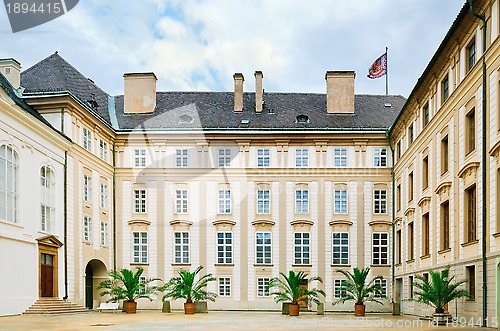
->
[325,71,356,114]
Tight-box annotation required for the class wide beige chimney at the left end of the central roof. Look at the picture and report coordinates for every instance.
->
[123,72,158,114]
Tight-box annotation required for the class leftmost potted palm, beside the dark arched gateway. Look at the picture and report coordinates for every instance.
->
[97,267,161,314]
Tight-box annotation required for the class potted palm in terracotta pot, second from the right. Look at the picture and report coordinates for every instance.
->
[333,267,384,316]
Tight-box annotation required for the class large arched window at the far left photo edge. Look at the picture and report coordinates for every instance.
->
[0,145,19,223]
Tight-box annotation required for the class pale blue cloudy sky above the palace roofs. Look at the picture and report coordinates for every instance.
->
[0,0,465,97]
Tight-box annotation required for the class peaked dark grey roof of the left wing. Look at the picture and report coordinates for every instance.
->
[21,52,110,123]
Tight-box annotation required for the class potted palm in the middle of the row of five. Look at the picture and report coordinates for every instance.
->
[268,270,325,316]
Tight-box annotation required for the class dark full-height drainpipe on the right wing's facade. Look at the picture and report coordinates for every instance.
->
[467,0,488,328]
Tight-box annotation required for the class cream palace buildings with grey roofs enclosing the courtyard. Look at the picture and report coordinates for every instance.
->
[0,0,500,318]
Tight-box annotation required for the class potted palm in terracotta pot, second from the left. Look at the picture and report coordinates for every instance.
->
[160,266,217,314]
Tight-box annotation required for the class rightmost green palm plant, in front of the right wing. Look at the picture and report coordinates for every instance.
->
[412,267,470,314]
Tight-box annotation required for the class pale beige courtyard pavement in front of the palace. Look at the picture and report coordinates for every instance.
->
[0,310,484,331]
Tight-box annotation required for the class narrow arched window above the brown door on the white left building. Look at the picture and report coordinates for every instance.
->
[40,166,56,232]
